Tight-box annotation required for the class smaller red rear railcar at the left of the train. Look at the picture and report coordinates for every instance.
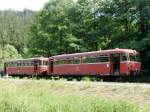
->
[4,57,48,75]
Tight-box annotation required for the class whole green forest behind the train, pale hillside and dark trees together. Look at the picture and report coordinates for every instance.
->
[0,0,150,73]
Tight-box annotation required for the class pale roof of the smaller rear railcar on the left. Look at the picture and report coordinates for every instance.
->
[6,57,48,62]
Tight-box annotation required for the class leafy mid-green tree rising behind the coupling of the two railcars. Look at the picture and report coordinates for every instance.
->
[29,0,79,56]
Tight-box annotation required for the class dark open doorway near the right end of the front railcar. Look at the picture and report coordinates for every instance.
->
[111,53,120,75]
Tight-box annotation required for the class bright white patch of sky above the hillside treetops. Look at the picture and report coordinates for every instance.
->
[0,0,49,11]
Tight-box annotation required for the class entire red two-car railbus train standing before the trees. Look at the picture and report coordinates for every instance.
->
[4,49,141,76]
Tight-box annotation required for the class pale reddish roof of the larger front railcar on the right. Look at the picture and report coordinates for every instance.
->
[51,48,138,60]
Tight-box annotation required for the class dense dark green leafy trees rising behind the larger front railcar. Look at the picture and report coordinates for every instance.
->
[30,0,150,71]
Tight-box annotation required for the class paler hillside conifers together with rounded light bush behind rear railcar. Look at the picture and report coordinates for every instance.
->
[0,10,33,67]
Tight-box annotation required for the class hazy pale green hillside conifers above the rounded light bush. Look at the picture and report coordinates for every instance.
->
[0,9,33,53]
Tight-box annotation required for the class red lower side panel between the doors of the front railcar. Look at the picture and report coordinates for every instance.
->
[53,62,111,75]
